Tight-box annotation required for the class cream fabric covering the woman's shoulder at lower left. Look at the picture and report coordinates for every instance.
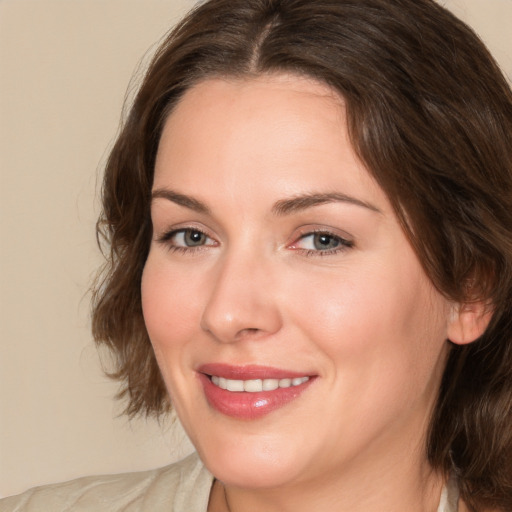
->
[0,454,213,512]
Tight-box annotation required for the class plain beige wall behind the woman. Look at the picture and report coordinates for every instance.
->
[0,0,512,496]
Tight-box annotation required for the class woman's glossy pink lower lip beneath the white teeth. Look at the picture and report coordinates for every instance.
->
[198,373,314,420]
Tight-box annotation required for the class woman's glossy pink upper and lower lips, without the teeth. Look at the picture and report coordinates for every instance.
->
[198,363,314,420]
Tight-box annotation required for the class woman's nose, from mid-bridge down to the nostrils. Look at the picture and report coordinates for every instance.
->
[201,250,281,343]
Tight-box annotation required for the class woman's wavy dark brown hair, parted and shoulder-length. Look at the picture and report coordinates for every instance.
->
[93,0,512,511]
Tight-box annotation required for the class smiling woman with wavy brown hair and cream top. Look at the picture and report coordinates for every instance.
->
[2,0,512,512]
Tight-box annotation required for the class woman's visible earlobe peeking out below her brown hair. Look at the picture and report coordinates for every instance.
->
[448,302,493,345]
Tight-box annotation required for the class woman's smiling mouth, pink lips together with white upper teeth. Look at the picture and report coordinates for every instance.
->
[197,364,316,420]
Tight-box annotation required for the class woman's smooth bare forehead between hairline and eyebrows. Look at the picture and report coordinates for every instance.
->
[155,75,381,210]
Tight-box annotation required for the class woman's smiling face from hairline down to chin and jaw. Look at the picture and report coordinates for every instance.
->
[142,75,452,488]
